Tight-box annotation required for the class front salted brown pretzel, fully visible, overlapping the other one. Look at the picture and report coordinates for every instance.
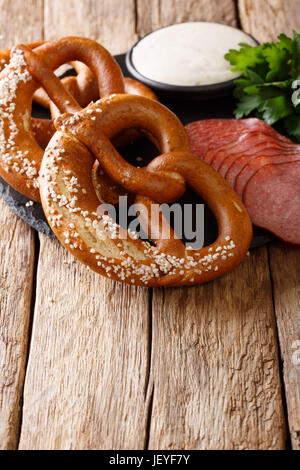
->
[40,95,252,286]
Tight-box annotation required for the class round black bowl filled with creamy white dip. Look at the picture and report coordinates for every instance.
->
[126,22,258,99]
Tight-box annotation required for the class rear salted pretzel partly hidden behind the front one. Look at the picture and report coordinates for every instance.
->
[0,37,124,201]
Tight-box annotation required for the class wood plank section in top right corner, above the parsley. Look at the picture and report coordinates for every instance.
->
[238,0,300,42]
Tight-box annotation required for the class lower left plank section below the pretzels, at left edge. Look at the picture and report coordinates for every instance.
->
[0,199,34,450]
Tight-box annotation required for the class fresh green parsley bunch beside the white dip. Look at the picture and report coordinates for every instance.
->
[225,31,300,141]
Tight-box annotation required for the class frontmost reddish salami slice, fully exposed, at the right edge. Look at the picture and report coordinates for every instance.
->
[244,161,300,244]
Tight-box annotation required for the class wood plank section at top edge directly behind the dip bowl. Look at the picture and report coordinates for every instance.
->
[137,0,236,37]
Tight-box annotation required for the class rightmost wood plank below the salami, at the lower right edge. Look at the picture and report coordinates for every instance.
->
[270,243,300,450]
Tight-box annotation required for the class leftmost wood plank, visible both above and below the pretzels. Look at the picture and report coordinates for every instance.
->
[0,0,43,449]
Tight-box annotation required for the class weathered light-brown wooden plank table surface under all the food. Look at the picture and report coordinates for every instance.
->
[0,0,300,449]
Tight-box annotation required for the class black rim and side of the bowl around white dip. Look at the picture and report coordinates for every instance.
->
[126,24,259,101]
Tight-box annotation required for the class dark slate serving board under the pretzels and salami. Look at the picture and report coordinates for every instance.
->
[0,54,274,248]
